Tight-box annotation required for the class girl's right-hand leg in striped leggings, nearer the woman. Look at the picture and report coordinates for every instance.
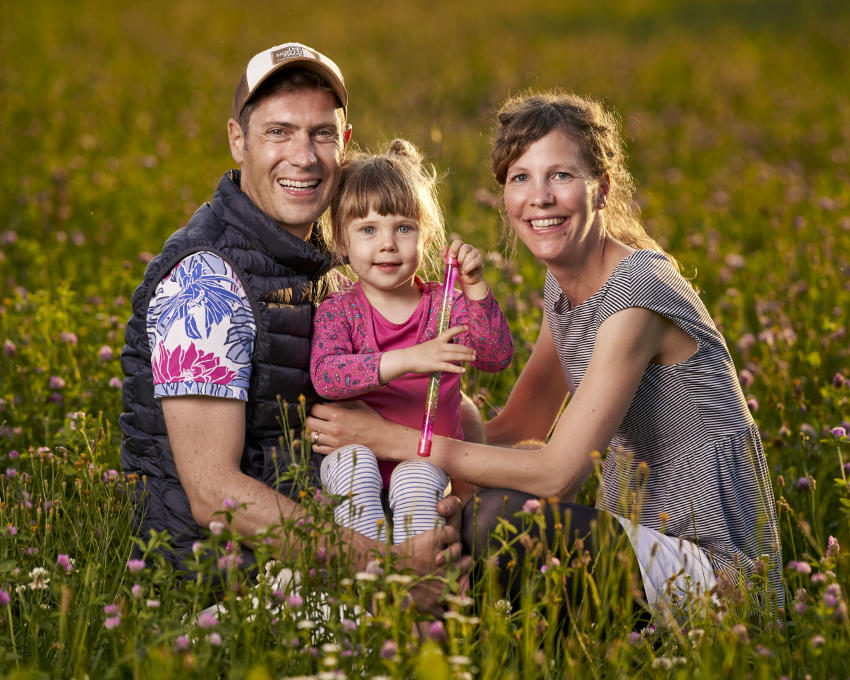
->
[389,460,449,543]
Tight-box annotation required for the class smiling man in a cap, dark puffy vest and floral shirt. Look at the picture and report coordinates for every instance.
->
[121,43,468,608]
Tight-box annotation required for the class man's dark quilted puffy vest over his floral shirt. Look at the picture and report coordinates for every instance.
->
[120,170,330,568]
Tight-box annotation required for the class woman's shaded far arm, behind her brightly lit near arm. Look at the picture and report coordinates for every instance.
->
[484,315,568,446]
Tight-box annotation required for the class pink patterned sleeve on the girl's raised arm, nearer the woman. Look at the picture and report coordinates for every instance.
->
[451,291,514,373]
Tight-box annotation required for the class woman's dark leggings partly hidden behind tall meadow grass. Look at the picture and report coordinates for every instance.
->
[462,489,646,615]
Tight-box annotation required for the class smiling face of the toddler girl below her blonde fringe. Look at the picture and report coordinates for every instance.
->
[342,210,422,292]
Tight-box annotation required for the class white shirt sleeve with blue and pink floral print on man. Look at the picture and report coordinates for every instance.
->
[147,251,257,401]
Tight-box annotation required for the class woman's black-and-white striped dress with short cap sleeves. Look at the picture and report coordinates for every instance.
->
[544,250,784,606]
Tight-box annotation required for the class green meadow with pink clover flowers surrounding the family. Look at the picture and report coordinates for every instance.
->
[0,0,850,680]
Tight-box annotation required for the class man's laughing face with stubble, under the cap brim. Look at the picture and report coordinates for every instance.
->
[228,89,350,239]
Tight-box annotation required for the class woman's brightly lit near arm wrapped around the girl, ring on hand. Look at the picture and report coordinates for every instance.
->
[307,308,669,498]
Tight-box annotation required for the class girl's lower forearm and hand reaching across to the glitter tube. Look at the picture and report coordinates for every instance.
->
[378,326,475,385]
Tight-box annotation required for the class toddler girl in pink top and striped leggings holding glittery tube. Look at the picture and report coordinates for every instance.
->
[310,140,513,543]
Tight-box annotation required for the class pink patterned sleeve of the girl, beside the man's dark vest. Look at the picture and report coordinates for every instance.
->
[310,295,382,399]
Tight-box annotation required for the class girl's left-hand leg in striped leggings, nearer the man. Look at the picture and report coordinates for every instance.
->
[319,445,387,541]
